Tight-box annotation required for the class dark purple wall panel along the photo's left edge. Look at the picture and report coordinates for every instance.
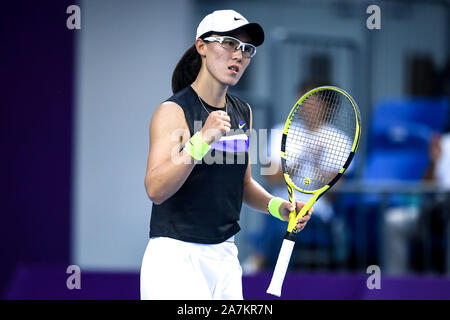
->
[0,0,74,298]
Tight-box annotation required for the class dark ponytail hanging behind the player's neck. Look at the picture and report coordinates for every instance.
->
[172,45,202,94]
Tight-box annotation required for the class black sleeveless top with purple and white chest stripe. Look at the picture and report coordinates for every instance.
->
[150,86,250,244]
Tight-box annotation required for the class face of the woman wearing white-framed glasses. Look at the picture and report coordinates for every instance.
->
[201,32,251,86]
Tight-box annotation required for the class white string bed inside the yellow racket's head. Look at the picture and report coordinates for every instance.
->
[285,89,356,190]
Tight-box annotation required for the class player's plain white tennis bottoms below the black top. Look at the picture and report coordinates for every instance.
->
[141,237,243,300]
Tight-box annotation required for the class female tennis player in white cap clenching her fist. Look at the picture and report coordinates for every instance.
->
[141,10,312,299]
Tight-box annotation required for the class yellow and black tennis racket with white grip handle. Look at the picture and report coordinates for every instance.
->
[267,86,361,297]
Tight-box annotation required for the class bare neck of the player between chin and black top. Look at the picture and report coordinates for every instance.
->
[192,72,228,108]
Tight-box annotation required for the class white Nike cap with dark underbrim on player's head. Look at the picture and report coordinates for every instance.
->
[195,10,264,46]
